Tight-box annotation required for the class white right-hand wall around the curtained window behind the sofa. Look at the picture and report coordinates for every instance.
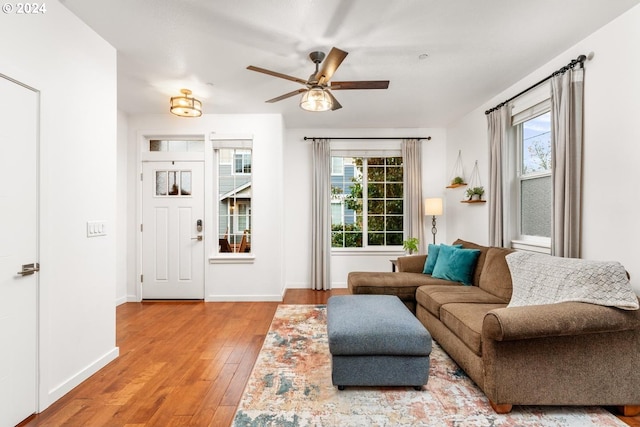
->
[447,6,640,294]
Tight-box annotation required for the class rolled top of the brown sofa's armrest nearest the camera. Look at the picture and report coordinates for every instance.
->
[482,302,640,341]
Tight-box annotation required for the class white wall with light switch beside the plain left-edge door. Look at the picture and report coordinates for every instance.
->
[0,0,118,410]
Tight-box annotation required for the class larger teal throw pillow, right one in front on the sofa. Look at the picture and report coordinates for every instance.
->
[431,245,480,285]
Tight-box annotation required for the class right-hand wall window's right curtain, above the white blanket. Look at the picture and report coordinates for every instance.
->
[551,68,584,258]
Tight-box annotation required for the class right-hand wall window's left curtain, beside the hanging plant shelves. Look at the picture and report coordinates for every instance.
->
[487,104,511,247]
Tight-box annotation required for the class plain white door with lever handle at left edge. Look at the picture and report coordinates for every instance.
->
[0,75,39,426]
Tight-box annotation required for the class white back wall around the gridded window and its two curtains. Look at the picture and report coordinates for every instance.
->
[284,129,448,288]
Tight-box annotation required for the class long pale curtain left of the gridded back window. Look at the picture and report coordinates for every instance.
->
[311,139,331,290]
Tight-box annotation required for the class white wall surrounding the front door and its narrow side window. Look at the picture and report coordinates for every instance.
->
[122,113,285,301]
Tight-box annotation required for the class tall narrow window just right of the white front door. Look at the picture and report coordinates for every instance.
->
[216,148,252,253]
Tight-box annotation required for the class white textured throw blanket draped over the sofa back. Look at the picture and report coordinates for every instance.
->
[506,252,638,310]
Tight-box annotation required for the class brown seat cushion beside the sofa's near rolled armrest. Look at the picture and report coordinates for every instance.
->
[440,303,507,356]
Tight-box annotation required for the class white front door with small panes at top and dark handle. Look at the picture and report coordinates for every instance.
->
[142,161,204,299]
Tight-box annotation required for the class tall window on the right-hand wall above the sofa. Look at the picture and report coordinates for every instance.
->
[516,111,552,242]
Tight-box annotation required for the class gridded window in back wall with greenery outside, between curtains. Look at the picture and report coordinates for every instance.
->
[331,156,403,248]
